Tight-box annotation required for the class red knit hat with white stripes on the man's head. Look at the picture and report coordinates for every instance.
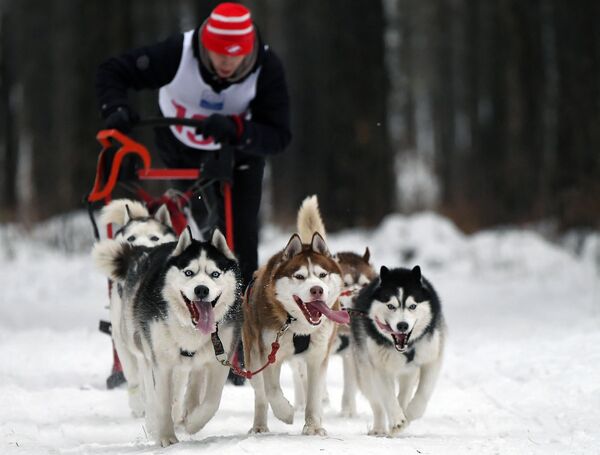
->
[201,3,254,55]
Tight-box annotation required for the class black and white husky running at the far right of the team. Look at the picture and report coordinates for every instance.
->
[351,266,446,436]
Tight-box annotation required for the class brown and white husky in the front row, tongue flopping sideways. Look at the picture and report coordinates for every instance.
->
[242,196,349,435]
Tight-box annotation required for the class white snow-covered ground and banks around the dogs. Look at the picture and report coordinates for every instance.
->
[0,214,600,455]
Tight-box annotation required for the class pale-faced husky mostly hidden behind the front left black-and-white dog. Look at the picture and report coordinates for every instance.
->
[100,199,177,417]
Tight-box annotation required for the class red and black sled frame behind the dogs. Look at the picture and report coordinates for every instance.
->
[86,117,234,389]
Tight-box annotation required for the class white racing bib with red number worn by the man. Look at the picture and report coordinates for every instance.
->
[158,30,260,150]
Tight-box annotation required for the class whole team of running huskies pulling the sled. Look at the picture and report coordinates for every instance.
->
[92,196,446,447]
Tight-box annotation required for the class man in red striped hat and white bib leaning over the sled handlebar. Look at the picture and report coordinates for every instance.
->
[96,3,291,290]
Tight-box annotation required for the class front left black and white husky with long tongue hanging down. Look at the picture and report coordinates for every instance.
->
[93,229,241,447]
